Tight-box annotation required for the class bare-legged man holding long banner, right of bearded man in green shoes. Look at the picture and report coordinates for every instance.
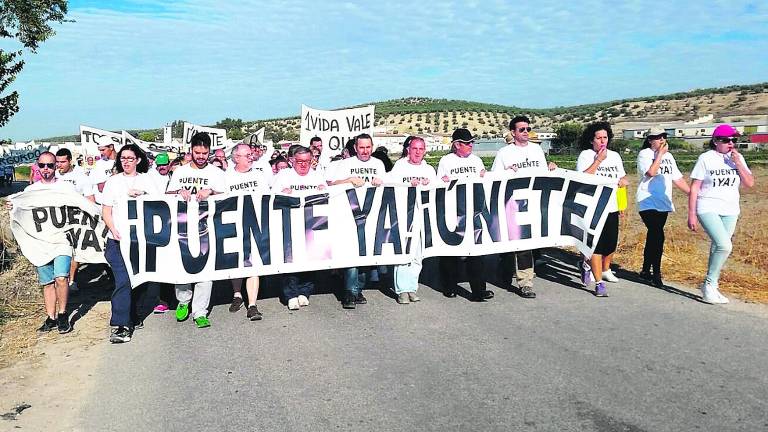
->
[225,143,271,321]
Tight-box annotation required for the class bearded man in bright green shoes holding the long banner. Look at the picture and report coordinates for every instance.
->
[166,132,227,328]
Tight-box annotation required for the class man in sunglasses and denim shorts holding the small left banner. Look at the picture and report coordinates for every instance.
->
[16,151,74,334]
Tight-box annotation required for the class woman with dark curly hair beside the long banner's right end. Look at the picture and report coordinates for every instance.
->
[576,122,628,297]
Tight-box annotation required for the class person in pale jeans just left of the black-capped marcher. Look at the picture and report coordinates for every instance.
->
[389,136,437,304]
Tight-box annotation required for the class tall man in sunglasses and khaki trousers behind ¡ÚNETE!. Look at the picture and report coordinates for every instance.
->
[491,116,557,299]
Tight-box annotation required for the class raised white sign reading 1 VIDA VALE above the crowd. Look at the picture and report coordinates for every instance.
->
[301,105,376,158]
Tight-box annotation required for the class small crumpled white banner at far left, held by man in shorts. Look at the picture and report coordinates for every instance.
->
[9,188,107,266]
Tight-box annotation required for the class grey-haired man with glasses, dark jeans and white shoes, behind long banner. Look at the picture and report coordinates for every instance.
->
[272,146,326,310]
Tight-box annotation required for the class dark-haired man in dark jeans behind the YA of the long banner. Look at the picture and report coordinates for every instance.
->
[326,134,386,309]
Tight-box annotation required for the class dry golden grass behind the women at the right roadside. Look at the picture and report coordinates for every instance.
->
[615,169,768,303]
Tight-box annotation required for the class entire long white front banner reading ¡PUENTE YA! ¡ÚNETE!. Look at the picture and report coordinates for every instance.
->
[108,170,615,286]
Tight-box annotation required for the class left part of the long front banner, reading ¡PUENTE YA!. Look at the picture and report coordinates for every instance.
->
[114,187,414,286]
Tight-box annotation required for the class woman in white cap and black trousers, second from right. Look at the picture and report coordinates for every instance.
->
[637,127,690,288]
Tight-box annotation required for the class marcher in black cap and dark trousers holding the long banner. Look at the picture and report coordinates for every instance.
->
[437,128,494,302]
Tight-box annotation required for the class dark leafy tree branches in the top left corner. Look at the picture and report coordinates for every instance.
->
[0,0,67,126]
